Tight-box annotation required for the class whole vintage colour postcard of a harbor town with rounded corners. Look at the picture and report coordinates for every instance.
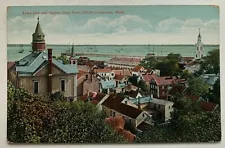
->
[7,5,221,144]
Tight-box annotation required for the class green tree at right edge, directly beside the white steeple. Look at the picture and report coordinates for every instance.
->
[199,49,220,74]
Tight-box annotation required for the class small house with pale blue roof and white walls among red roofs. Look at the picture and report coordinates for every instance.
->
[99,80,116,94]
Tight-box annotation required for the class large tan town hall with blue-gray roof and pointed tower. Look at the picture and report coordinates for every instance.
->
[8,18,78,98]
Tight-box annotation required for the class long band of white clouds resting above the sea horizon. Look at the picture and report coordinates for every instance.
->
[8,15,219,44]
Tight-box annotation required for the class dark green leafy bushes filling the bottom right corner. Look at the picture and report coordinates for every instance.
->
[136,98,221,143]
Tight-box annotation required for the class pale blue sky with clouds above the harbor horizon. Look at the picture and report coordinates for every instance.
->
[7,5,219,44]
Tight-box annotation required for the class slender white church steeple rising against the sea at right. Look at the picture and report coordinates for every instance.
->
[195,29,204,59]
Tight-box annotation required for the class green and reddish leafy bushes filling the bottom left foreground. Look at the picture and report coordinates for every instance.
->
[7,83,126,143]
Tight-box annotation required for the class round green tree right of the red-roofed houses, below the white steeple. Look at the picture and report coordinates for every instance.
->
[187,77,209,96]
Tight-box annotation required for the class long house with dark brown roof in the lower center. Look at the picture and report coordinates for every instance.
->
[102,94,148,127]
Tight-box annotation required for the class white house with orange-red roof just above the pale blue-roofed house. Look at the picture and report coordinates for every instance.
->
[93,68,115,80]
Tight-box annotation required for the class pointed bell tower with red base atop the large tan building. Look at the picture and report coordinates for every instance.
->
[32,16,45,51]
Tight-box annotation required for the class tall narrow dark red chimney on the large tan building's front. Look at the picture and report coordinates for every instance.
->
[48,48,52,94]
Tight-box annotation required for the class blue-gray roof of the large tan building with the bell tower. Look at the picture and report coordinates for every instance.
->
[16,51,78,76]
